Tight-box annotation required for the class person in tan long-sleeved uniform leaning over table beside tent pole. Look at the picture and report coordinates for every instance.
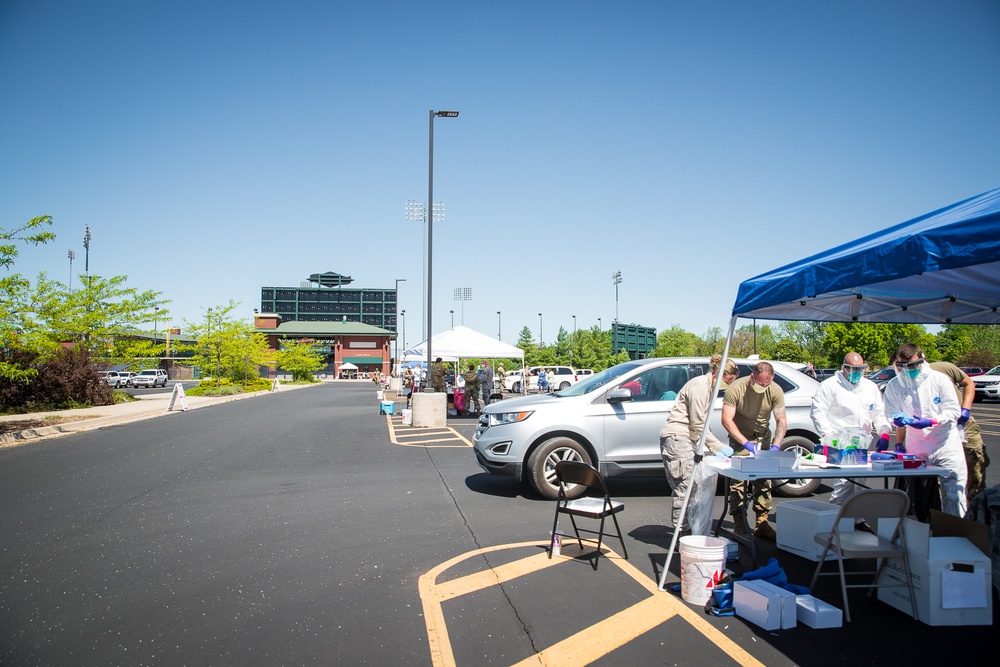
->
[660,354,740,535]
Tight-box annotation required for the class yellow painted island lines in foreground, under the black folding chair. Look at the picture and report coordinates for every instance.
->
[418,542,763,667]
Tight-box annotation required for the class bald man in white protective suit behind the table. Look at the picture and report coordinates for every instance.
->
[809,352,892,505]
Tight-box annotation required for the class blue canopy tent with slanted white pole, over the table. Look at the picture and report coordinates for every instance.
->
[660,188,1000,590]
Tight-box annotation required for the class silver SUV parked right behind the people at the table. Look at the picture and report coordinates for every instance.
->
[475,357,819,498]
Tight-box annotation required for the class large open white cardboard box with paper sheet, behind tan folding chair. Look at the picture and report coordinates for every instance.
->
[878,519,993,625]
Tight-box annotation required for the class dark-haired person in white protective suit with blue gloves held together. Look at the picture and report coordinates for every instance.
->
[885,343,968,516]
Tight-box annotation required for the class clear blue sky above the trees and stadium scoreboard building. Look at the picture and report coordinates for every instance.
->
[0,0,1000,350]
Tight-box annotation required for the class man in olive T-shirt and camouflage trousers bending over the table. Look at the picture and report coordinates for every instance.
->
[722,361,788,540]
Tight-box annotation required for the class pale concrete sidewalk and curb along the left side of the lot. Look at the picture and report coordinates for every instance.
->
[0,383,321,449]
